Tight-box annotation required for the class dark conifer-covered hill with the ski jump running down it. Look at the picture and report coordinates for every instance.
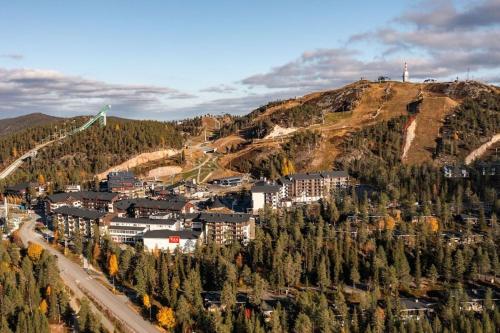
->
[0,117,184,188]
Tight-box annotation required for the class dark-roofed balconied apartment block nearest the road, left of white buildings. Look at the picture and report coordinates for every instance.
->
[53,206,106,238]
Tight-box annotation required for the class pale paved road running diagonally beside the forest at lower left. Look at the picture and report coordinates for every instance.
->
[20,220,159,333]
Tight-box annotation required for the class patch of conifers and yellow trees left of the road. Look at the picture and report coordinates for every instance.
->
[0,233,104,333]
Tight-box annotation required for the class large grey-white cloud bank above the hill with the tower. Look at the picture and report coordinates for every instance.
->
[241,0,500,90]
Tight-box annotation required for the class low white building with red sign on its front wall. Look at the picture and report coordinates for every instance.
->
[143,229,202,253]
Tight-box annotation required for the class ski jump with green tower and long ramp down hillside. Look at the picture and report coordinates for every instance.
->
[0,105,111,179]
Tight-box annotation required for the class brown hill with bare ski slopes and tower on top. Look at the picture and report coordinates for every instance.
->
[214,81,500,178]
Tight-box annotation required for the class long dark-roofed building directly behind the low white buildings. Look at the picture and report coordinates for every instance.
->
[114,196,194,218]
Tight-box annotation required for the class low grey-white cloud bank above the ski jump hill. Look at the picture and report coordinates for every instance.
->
[0,68,196,118]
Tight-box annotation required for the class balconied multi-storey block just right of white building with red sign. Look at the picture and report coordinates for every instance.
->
[198,213,255,244]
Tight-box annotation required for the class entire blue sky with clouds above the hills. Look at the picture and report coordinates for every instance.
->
[0,0,500,120]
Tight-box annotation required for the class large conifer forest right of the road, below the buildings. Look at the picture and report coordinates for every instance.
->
[52,194,500,333]
